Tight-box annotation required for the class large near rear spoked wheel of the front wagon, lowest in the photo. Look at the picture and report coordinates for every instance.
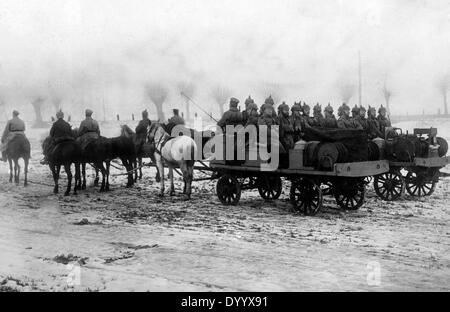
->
[290,178,322,216]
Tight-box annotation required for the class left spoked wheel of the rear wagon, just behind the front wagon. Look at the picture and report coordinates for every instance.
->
[373,171,405,201]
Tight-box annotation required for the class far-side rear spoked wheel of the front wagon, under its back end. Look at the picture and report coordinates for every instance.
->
[333,179,365,210]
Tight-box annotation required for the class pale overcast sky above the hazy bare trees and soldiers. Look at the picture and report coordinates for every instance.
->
[0,0,450,119]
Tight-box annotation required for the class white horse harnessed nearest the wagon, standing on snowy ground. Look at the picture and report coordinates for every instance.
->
[148,122,197,200]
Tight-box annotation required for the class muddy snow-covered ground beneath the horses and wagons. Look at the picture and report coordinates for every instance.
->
[0,119,450,291]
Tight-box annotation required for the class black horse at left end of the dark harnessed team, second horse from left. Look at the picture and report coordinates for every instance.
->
[42,137,81,196]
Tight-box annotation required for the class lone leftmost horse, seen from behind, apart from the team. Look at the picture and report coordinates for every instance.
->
[5,135,31,186]
